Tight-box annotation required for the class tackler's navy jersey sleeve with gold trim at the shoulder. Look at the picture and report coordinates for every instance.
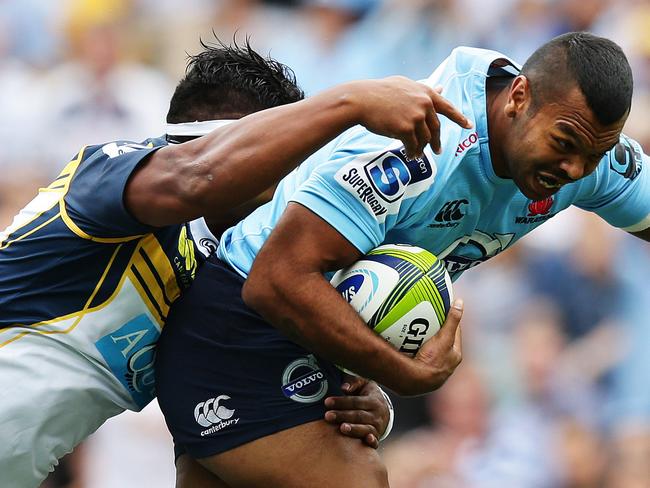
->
[64,139,165,240]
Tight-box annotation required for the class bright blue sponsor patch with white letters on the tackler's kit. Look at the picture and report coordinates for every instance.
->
[95,314,160,408]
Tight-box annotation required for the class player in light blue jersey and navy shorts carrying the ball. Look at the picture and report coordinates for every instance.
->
[156,33,650,487]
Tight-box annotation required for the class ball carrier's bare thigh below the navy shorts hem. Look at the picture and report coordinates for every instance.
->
[199,420,388,488]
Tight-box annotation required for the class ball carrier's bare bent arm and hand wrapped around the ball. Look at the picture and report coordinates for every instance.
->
[242,203,462,395]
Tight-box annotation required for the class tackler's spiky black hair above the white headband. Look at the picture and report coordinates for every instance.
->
[167,36,305,124]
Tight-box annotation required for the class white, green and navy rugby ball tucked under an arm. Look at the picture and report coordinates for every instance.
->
[330,244,453,355]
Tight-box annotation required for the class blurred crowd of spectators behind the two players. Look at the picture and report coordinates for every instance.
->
[0,0,650,488]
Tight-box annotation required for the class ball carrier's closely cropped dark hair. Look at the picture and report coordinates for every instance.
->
[521,32,633,125]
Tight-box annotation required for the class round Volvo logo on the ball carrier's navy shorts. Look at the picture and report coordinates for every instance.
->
[282,354,328,403]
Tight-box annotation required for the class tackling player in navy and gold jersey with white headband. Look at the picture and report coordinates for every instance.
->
[0,39,464,488]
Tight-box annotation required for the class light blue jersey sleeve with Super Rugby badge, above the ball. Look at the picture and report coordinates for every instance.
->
[291,128,435,253]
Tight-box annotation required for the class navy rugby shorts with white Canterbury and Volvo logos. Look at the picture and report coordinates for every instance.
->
[156,257,343,458]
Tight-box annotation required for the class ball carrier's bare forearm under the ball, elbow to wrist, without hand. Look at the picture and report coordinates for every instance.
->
[243,269,444,395]
